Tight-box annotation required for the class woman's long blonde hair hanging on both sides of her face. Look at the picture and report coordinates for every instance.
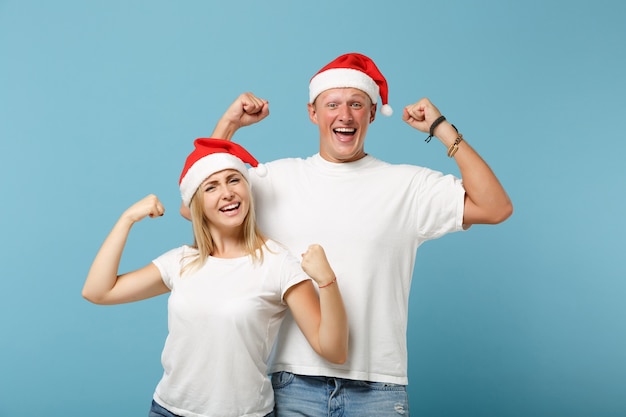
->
[180,176,267,276]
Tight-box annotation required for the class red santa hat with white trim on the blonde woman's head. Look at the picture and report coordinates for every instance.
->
[178,138,265,207]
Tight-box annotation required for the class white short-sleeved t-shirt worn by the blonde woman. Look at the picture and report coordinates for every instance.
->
[153,241,309,417]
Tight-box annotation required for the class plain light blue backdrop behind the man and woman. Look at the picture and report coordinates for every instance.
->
[0,0,626,417]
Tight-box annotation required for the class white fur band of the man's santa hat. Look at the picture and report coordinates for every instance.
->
[309,68,379,104]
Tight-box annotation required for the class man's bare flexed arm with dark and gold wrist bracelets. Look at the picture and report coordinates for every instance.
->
[402,98,513,225]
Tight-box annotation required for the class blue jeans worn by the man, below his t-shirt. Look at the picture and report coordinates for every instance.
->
[272,372,409,417]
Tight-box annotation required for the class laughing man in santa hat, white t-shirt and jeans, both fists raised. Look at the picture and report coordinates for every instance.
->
[189,53,513,417]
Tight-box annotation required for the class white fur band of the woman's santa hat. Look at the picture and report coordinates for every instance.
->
[180,152,250,207]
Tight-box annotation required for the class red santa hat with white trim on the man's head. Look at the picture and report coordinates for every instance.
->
[309,53,393,116]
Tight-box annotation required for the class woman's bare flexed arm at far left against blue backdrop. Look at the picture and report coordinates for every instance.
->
[82,195,169,304]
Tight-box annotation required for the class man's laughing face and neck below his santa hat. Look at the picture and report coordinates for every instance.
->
[308,88,376,162]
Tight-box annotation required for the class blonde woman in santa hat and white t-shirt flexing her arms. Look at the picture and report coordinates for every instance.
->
[83,139,348,416]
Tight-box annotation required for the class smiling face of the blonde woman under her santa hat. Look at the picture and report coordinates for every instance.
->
[199,169,250,232]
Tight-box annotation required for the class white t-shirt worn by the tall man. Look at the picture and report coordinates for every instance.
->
[250,154,465,384]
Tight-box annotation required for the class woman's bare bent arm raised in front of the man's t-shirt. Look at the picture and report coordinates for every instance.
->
[285,245,348,363]
